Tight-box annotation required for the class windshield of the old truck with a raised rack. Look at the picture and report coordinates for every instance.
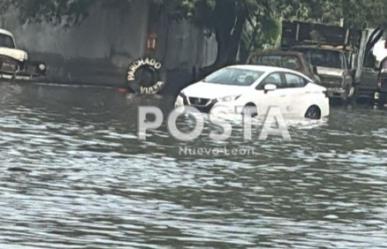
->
[300,49,345,69]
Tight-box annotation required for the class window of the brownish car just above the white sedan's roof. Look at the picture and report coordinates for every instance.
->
[250,55,301,70]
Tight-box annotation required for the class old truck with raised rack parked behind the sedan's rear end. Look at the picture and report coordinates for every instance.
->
[282,22,361,100]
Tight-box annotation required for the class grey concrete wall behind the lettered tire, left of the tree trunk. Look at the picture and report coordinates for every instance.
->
[0,0,216,88]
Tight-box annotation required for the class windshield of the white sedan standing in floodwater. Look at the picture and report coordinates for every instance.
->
[204,68,264,86]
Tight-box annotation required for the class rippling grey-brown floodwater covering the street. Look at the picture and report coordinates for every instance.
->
[0,83,387,249]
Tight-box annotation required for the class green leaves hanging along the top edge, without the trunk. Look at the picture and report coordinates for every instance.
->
[0,0,387,29]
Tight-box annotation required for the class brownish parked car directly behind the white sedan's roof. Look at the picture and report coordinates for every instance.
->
[247,50,320,84]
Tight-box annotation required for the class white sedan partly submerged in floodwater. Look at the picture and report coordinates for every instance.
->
[176,65,330,120]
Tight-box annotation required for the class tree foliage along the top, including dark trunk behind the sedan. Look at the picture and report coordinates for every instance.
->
[0,0,387,66]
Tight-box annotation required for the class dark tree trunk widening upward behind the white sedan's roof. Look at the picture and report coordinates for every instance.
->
[171,0,271,69]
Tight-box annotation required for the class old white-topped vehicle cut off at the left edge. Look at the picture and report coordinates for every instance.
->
[0,29,47,80]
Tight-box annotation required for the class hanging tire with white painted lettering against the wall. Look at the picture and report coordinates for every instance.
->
[127,58,166,95]
